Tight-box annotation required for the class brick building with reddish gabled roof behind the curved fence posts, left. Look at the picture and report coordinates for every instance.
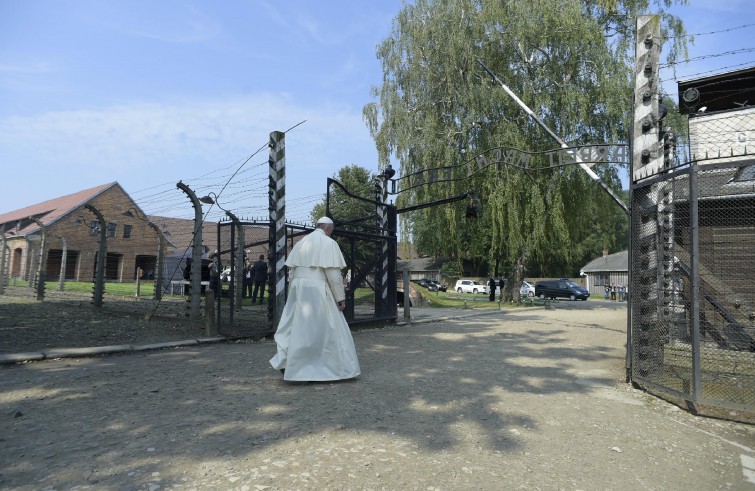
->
[0,182,224,282]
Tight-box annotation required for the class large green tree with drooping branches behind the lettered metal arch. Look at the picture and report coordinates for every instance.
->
[364,0,684,296]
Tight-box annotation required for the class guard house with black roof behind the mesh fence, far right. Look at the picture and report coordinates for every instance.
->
[674,67,755,350]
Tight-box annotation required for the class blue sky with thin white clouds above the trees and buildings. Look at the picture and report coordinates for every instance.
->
[0,0,755,221]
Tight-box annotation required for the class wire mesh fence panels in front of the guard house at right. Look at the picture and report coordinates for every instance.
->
[629,140,755,418]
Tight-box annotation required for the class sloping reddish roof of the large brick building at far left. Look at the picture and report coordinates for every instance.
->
[0,182,119,236]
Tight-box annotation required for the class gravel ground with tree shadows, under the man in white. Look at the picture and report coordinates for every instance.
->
[0,292,755,491]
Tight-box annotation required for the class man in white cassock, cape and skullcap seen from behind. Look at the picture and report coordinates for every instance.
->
[270,217,360,382]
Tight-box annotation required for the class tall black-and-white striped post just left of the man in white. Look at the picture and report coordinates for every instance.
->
[268,131,286,330]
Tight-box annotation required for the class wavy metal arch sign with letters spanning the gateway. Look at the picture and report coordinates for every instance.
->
[390,145,629,194]
